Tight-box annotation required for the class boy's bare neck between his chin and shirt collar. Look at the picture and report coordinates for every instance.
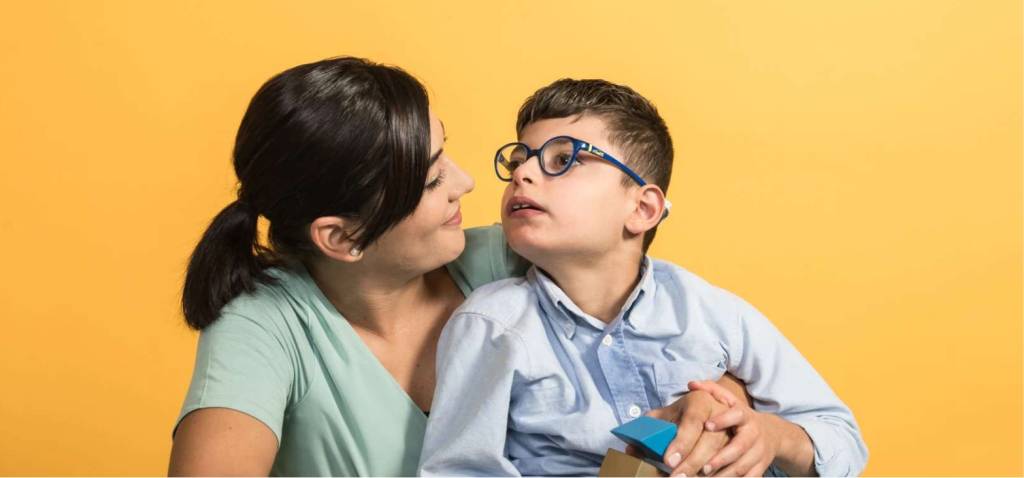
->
[537,251,644,323]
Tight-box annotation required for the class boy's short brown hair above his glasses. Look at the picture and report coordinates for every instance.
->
[515,78,673,250]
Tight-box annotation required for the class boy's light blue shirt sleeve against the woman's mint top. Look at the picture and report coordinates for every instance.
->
[419,313,525,476]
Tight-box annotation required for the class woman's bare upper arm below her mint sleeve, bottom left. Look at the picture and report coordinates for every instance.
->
[167,408,278,476]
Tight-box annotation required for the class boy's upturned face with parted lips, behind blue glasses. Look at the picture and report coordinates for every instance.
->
[502,116,636,267]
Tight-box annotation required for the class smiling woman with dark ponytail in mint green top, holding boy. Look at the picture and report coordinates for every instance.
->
[170,57,742,476]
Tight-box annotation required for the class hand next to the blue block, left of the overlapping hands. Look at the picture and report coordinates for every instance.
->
[626,388,732,476]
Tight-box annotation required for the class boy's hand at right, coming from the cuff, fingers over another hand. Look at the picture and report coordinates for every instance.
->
[687,382,780,476]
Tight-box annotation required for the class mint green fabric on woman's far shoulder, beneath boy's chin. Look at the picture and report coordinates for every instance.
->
[447,224,530,296]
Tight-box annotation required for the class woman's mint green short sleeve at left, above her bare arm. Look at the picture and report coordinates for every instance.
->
[175,313,294,443]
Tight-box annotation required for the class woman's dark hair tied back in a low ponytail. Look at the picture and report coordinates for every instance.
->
[181,57,430,330]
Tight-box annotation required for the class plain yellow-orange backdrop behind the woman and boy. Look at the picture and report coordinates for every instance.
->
[0,0,1024,475]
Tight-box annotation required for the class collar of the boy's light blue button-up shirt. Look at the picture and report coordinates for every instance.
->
[526,256,658,339]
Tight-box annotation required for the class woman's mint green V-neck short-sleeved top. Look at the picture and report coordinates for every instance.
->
[178,225,528,476]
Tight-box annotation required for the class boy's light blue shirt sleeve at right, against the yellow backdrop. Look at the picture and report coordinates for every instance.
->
[729,300,867,476]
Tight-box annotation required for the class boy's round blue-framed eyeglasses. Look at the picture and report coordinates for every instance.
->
[495,136,647,186]
